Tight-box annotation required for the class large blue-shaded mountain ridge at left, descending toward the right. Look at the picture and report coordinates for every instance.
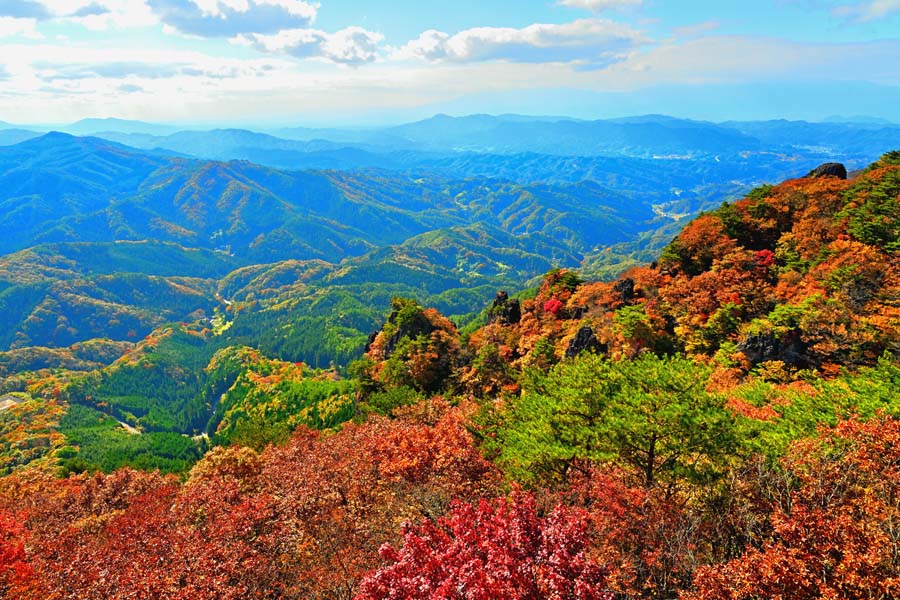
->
[0,133,653,262]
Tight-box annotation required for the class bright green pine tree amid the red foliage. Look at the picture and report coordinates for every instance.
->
[489,354,737,487]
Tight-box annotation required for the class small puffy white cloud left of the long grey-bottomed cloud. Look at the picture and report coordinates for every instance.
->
[232,27,384,65]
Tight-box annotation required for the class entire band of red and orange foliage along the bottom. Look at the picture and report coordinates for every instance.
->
[0,396,900,600]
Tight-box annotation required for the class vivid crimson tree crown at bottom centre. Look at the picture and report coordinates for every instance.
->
[357,494,612,600]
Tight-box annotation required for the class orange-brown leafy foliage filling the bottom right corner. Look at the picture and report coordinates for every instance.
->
[687,417,900,600]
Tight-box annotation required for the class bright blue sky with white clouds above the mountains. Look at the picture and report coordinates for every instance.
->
[0,0,900,126]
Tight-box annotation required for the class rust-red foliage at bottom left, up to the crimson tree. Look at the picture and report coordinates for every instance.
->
[0,401,499,600]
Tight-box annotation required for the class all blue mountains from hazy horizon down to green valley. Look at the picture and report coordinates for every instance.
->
[0,115,900,365]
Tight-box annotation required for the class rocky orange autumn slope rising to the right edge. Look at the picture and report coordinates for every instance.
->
[454,152,900,381]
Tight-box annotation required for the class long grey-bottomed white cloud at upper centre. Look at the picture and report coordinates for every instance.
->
[398,19,648,68]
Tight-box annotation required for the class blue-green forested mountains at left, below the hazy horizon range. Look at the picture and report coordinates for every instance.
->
[0,133,668,364]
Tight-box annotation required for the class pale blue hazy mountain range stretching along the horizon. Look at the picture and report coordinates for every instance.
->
[0,115,900,168]
